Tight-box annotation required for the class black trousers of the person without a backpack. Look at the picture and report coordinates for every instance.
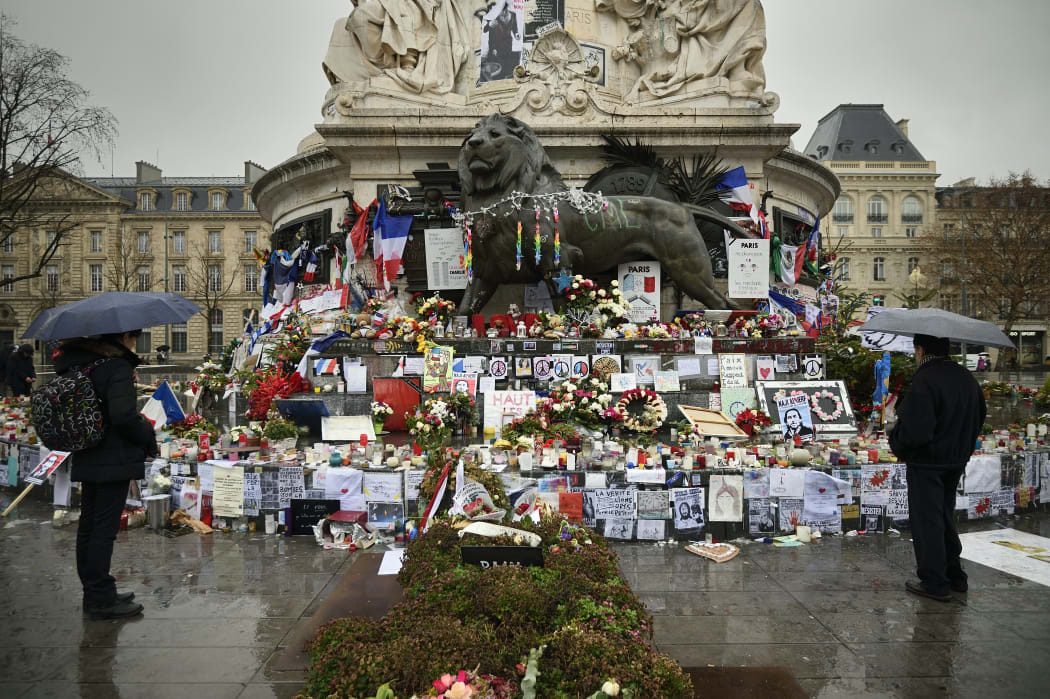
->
[908,466,966,593]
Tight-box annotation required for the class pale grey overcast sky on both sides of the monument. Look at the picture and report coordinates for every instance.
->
[0,0,1050,186]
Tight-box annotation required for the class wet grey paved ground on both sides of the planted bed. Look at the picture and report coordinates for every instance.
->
[0,489,1050,699]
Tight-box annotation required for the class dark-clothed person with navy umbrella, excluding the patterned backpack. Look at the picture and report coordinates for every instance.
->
[25,292,201,619]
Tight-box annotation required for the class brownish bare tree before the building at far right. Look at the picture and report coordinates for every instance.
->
[937,172,1050,358]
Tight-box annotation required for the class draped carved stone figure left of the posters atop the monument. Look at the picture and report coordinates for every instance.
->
[322,0,478,94]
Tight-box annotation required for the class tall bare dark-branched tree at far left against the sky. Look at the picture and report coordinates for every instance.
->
[0,14,117,283]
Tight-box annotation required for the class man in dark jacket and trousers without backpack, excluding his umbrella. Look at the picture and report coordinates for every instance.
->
[889,335,987,601]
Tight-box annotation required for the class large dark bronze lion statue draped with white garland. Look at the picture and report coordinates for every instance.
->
[458,114,735,314]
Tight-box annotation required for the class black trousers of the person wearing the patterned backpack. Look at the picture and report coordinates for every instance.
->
[77,481,129,607]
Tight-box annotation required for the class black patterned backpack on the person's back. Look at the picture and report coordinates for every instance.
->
[30,359,106,451]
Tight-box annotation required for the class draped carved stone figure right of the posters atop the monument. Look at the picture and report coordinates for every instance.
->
[594,0,765,100]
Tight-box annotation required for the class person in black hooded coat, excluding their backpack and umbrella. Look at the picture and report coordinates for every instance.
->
[55,331,158,619]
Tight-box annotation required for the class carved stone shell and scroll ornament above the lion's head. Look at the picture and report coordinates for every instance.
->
[507,29,599,115]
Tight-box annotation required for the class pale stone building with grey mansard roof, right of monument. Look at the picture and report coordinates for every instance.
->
[805,104,938,305]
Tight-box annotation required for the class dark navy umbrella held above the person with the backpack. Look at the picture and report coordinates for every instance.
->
[22,292,201,340]
